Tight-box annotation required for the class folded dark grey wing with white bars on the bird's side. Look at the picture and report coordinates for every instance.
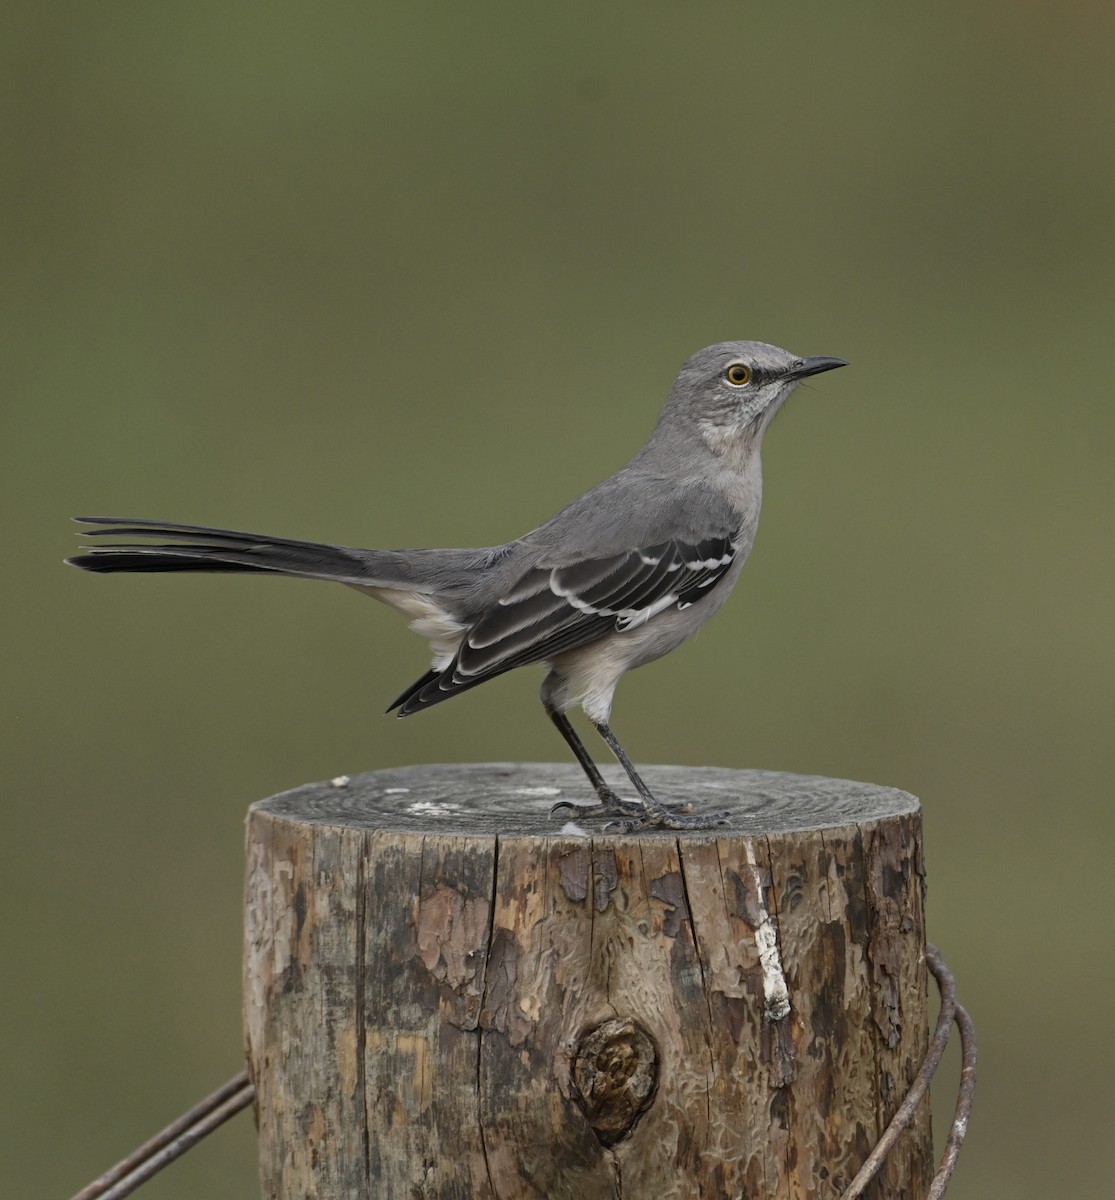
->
[391,534,736,716]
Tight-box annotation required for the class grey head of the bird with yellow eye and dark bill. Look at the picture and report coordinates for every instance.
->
[663,342,847,463]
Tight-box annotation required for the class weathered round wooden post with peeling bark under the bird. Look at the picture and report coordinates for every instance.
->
[245,763,933,1200]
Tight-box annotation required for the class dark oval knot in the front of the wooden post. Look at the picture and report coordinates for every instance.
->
[574,1020,658,1146]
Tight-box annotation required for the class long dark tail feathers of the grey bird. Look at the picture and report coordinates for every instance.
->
[66,517,416,587]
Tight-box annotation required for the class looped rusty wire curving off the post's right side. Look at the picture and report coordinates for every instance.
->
[840,946,976,1200]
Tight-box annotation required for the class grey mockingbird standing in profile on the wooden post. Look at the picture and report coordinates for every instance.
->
[67,342,847,829]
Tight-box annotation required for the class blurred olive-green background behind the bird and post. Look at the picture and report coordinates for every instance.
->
[0,0,1115,1200]
